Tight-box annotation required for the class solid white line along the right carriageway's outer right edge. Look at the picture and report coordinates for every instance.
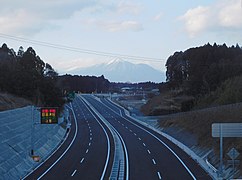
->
[103,98,196,180]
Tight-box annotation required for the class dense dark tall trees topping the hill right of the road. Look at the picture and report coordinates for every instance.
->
[166,43,242,97]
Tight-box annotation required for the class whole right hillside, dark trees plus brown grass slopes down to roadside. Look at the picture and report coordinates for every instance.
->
[141,44,242,177]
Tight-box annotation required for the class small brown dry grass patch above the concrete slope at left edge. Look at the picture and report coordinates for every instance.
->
[0,93,32,111]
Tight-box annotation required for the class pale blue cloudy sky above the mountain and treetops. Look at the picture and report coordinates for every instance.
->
[0,0,242,74]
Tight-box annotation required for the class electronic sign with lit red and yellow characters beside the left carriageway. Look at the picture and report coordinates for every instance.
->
[40,108,58,124]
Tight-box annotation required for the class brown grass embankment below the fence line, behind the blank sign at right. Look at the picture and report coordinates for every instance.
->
[159,103,242,169]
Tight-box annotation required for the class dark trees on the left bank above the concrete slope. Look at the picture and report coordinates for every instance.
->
[0,44,64,107]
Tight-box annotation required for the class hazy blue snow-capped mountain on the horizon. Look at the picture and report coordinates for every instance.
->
[70,60,165,83]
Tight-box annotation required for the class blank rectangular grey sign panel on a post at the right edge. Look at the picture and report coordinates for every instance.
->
[212,123,242,137]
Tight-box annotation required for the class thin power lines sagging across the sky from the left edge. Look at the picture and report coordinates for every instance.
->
[0,33,163,62]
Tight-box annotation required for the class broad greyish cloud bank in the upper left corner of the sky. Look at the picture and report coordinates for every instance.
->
[0,0,99,35]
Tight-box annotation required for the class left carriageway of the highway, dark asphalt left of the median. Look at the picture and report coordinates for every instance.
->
[25,99,114,180]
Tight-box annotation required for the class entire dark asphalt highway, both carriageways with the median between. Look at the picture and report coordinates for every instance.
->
[25,95,211,180]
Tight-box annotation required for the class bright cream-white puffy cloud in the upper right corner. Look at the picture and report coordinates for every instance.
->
[178,0,242,37]
